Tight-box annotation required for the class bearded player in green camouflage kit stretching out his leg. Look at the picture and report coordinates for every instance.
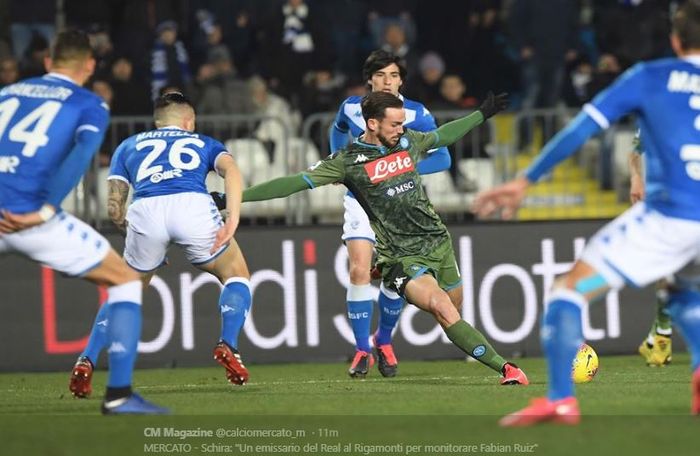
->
[243,92,528,385]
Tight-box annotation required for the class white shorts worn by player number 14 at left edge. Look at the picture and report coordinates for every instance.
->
[0,212,111,277]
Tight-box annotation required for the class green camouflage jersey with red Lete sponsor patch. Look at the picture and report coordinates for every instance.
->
[302,130,449,258]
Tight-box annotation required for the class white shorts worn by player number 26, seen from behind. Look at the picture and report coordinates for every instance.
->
[124,193,226,272]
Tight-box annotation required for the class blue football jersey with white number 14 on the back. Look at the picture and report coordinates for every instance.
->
[0,73,109,213]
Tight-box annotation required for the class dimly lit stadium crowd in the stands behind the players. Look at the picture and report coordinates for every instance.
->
[0,0,677,117]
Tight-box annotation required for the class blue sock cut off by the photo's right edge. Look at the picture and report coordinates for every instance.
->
[667,290,700,371]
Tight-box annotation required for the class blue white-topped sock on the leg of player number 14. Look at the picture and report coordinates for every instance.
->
[107,302,141,388]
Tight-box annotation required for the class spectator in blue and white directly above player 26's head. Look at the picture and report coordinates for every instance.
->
[151,21,192,100]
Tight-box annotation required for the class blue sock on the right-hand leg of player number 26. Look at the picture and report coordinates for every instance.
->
[219,277,251,349]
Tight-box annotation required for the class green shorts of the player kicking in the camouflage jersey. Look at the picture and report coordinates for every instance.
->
[377,236,462,296]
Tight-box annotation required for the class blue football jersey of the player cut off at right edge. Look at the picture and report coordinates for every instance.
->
[584,57,700,220]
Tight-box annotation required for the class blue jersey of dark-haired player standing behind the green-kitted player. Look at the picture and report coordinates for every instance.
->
[331,95,437,147]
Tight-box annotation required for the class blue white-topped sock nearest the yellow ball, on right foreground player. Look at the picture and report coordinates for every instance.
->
[541,290,586,401]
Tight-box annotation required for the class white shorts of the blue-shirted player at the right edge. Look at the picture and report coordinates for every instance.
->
[581,202,700,289]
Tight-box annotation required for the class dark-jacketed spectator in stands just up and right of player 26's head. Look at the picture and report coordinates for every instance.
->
[194,47,255,114]
